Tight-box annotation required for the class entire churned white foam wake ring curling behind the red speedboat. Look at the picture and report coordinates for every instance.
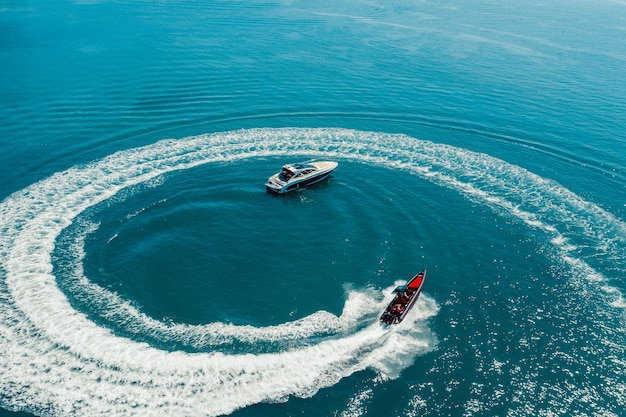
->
[0,129,626,416]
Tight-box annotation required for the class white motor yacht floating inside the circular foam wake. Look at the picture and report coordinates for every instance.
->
[265,161,339,194]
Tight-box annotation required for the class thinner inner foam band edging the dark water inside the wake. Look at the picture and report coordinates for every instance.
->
[53,221,372,352]
